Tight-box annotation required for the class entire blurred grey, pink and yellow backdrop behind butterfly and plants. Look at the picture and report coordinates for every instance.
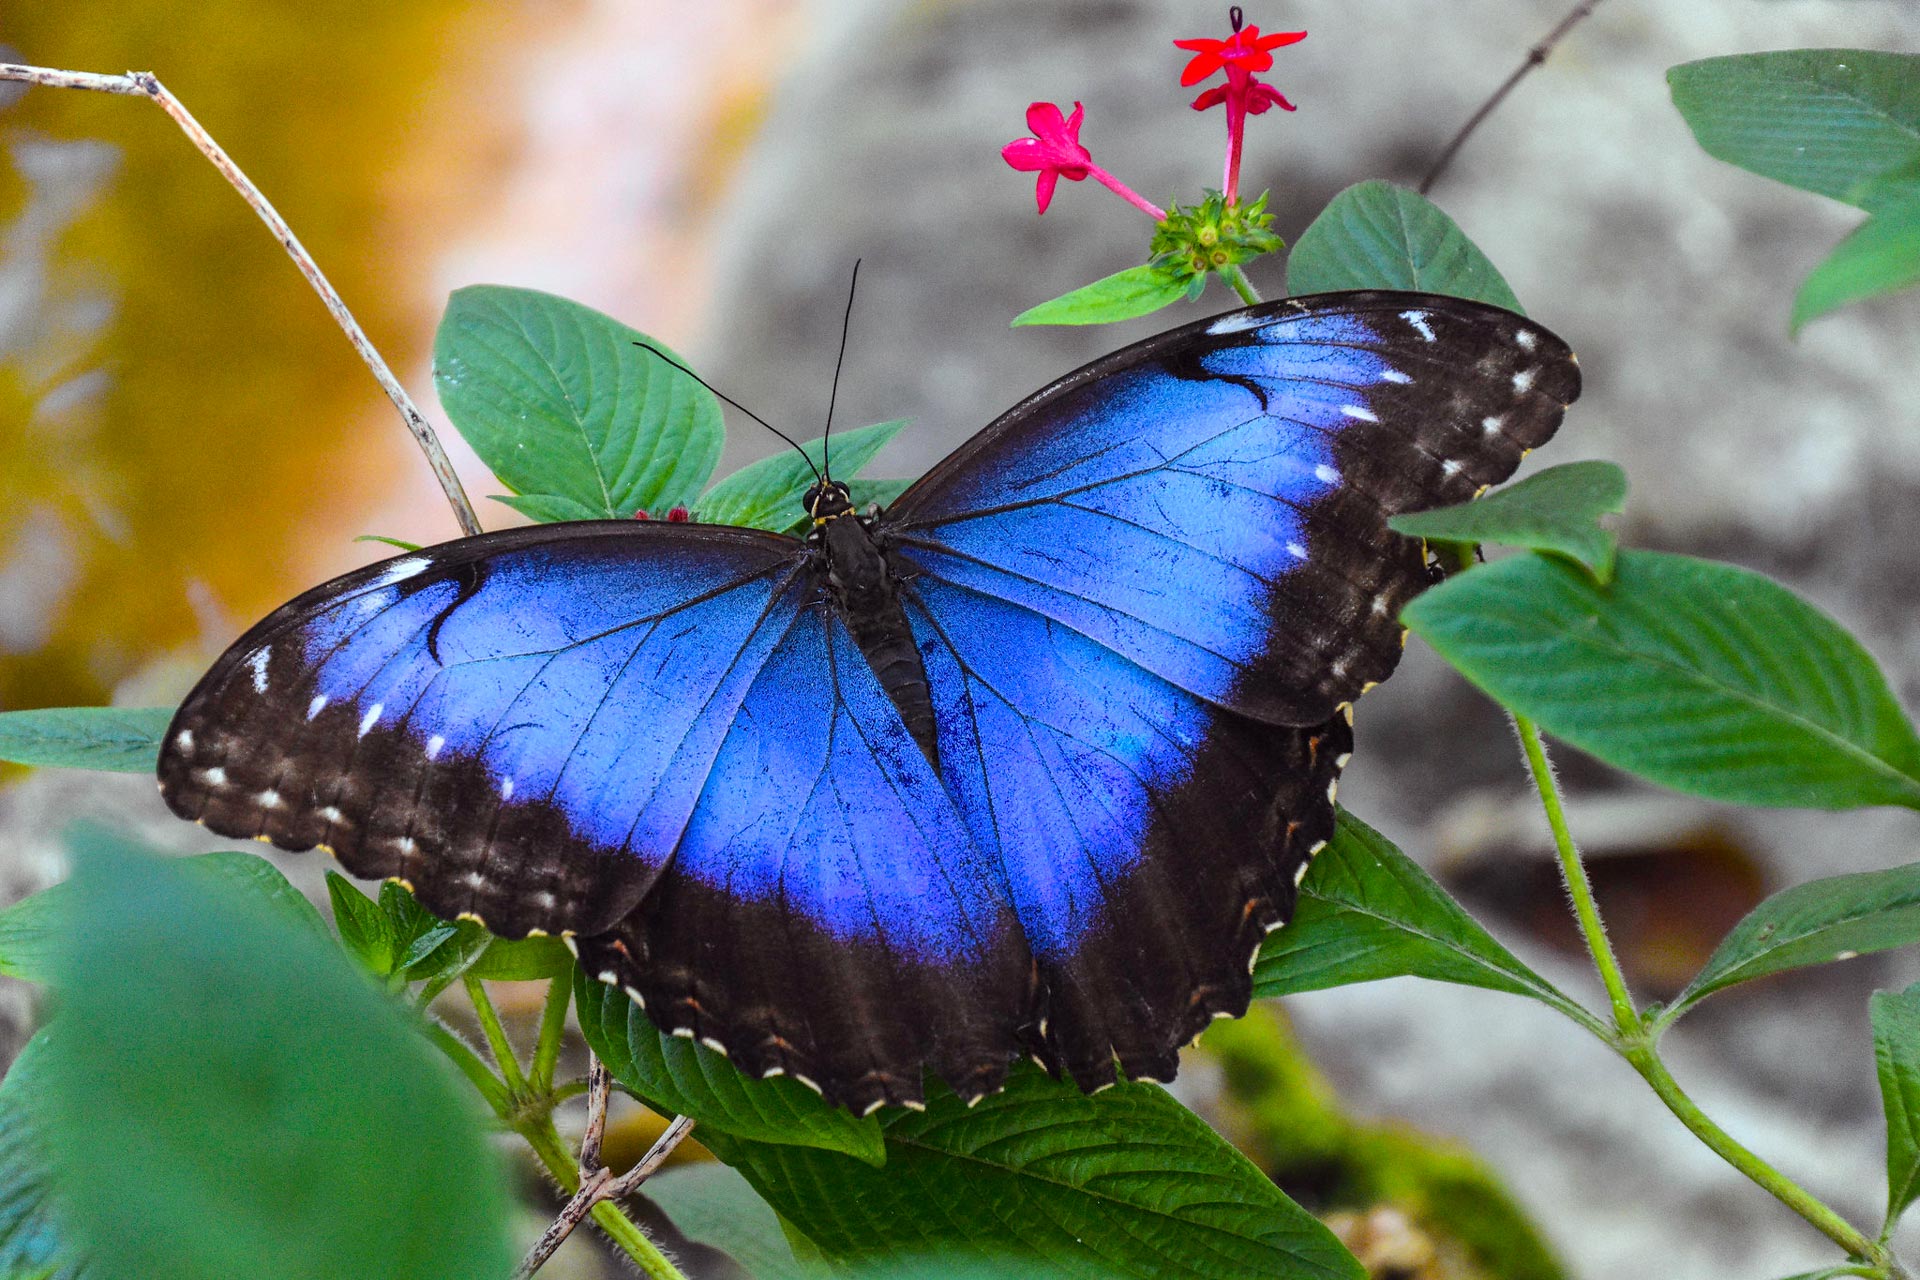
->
[0,0,1920,1280]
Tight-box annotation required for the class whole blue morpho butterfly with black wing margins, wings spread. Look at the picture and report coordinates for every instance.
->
[159,294,1580,1111]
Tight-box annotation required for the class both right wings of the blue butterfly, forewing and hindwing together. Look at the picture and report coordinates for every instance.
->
[879,294,1580,1086]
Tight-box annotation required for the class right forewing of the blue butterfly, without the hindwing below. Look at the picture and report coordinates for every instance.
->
[885,294,1580,725]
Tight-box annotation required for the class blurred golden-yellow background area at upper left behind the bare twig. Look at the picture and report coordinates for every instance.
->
[0,0,553,708]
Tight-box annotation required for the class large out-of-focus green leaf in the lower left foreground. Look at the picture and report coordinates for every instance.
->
[33,835,515,1280]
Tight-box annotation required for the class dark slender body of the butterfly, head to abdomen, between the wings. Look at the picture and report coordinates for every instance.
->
[806,482,939,766]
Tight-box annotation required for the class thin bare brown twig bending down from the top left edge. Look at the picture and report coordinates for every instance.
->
[0,63,480,535]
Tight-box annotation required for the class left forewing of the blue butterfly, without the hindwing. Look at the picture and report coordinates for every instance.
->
[159,522,799,936]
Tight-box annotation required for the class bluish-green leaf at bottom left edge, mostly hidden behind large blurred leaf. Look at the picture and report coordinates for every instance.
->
[0,1029,98,1280]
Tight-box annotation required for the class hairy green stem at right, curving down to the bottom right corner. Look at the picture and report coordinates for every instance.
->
[1513,712,1901,1278]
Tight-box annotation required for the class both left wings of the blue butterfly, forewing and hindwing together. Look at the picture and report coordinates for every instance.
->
[159,522,1039,1109]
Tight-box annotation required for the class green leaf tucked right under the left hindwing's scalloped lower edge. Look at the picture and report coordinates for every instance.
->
[574,971,885,1163]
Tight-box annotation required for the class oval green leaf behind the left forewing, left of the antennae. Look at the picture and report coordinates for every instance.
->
[434,284,724,520]
